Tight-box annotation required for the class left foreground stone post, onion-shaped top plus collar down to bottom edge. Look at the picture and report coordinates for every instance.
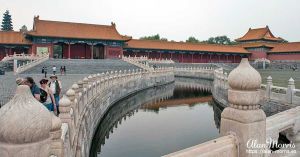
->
[0,85,53,157]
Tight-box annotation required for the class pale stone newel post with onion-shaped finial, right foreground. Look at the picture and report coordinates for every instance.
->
[220,58,266,157]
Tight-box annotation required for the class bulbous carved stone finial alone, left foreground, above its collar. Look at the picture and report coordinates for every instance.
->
[0,85,51,144]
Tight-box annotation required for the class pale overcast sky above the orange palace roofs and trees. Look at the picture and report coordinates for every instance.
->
[0,0,300,41]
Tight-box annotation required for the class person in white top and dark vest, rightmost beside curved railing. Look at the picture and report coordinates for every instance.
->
[49,75,61,115]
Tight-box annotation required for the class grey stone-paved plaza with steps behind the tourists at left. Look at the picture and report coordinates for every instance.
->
[0,59,138,106]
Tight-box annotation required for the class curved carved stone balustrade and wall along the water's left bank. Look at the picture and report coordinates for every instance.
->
[59,68,174,157]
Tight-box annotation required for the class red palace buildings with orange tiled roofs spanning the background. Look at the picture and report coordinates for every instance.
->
[0,16,300,63]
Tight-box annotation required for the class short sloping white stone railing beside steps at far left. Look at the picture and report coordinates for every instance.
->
[14,55,49,74]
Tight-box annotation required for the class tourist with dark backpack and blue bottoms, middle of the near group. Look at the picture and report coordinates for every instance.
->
[40,79,57,112]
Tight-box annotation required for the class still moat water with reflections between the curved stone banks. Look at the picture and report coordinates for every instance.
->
[90,79,221,157]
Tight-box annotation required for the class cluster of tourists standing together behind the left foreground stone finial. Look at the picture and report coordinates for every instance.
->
[16,75,62,116]
